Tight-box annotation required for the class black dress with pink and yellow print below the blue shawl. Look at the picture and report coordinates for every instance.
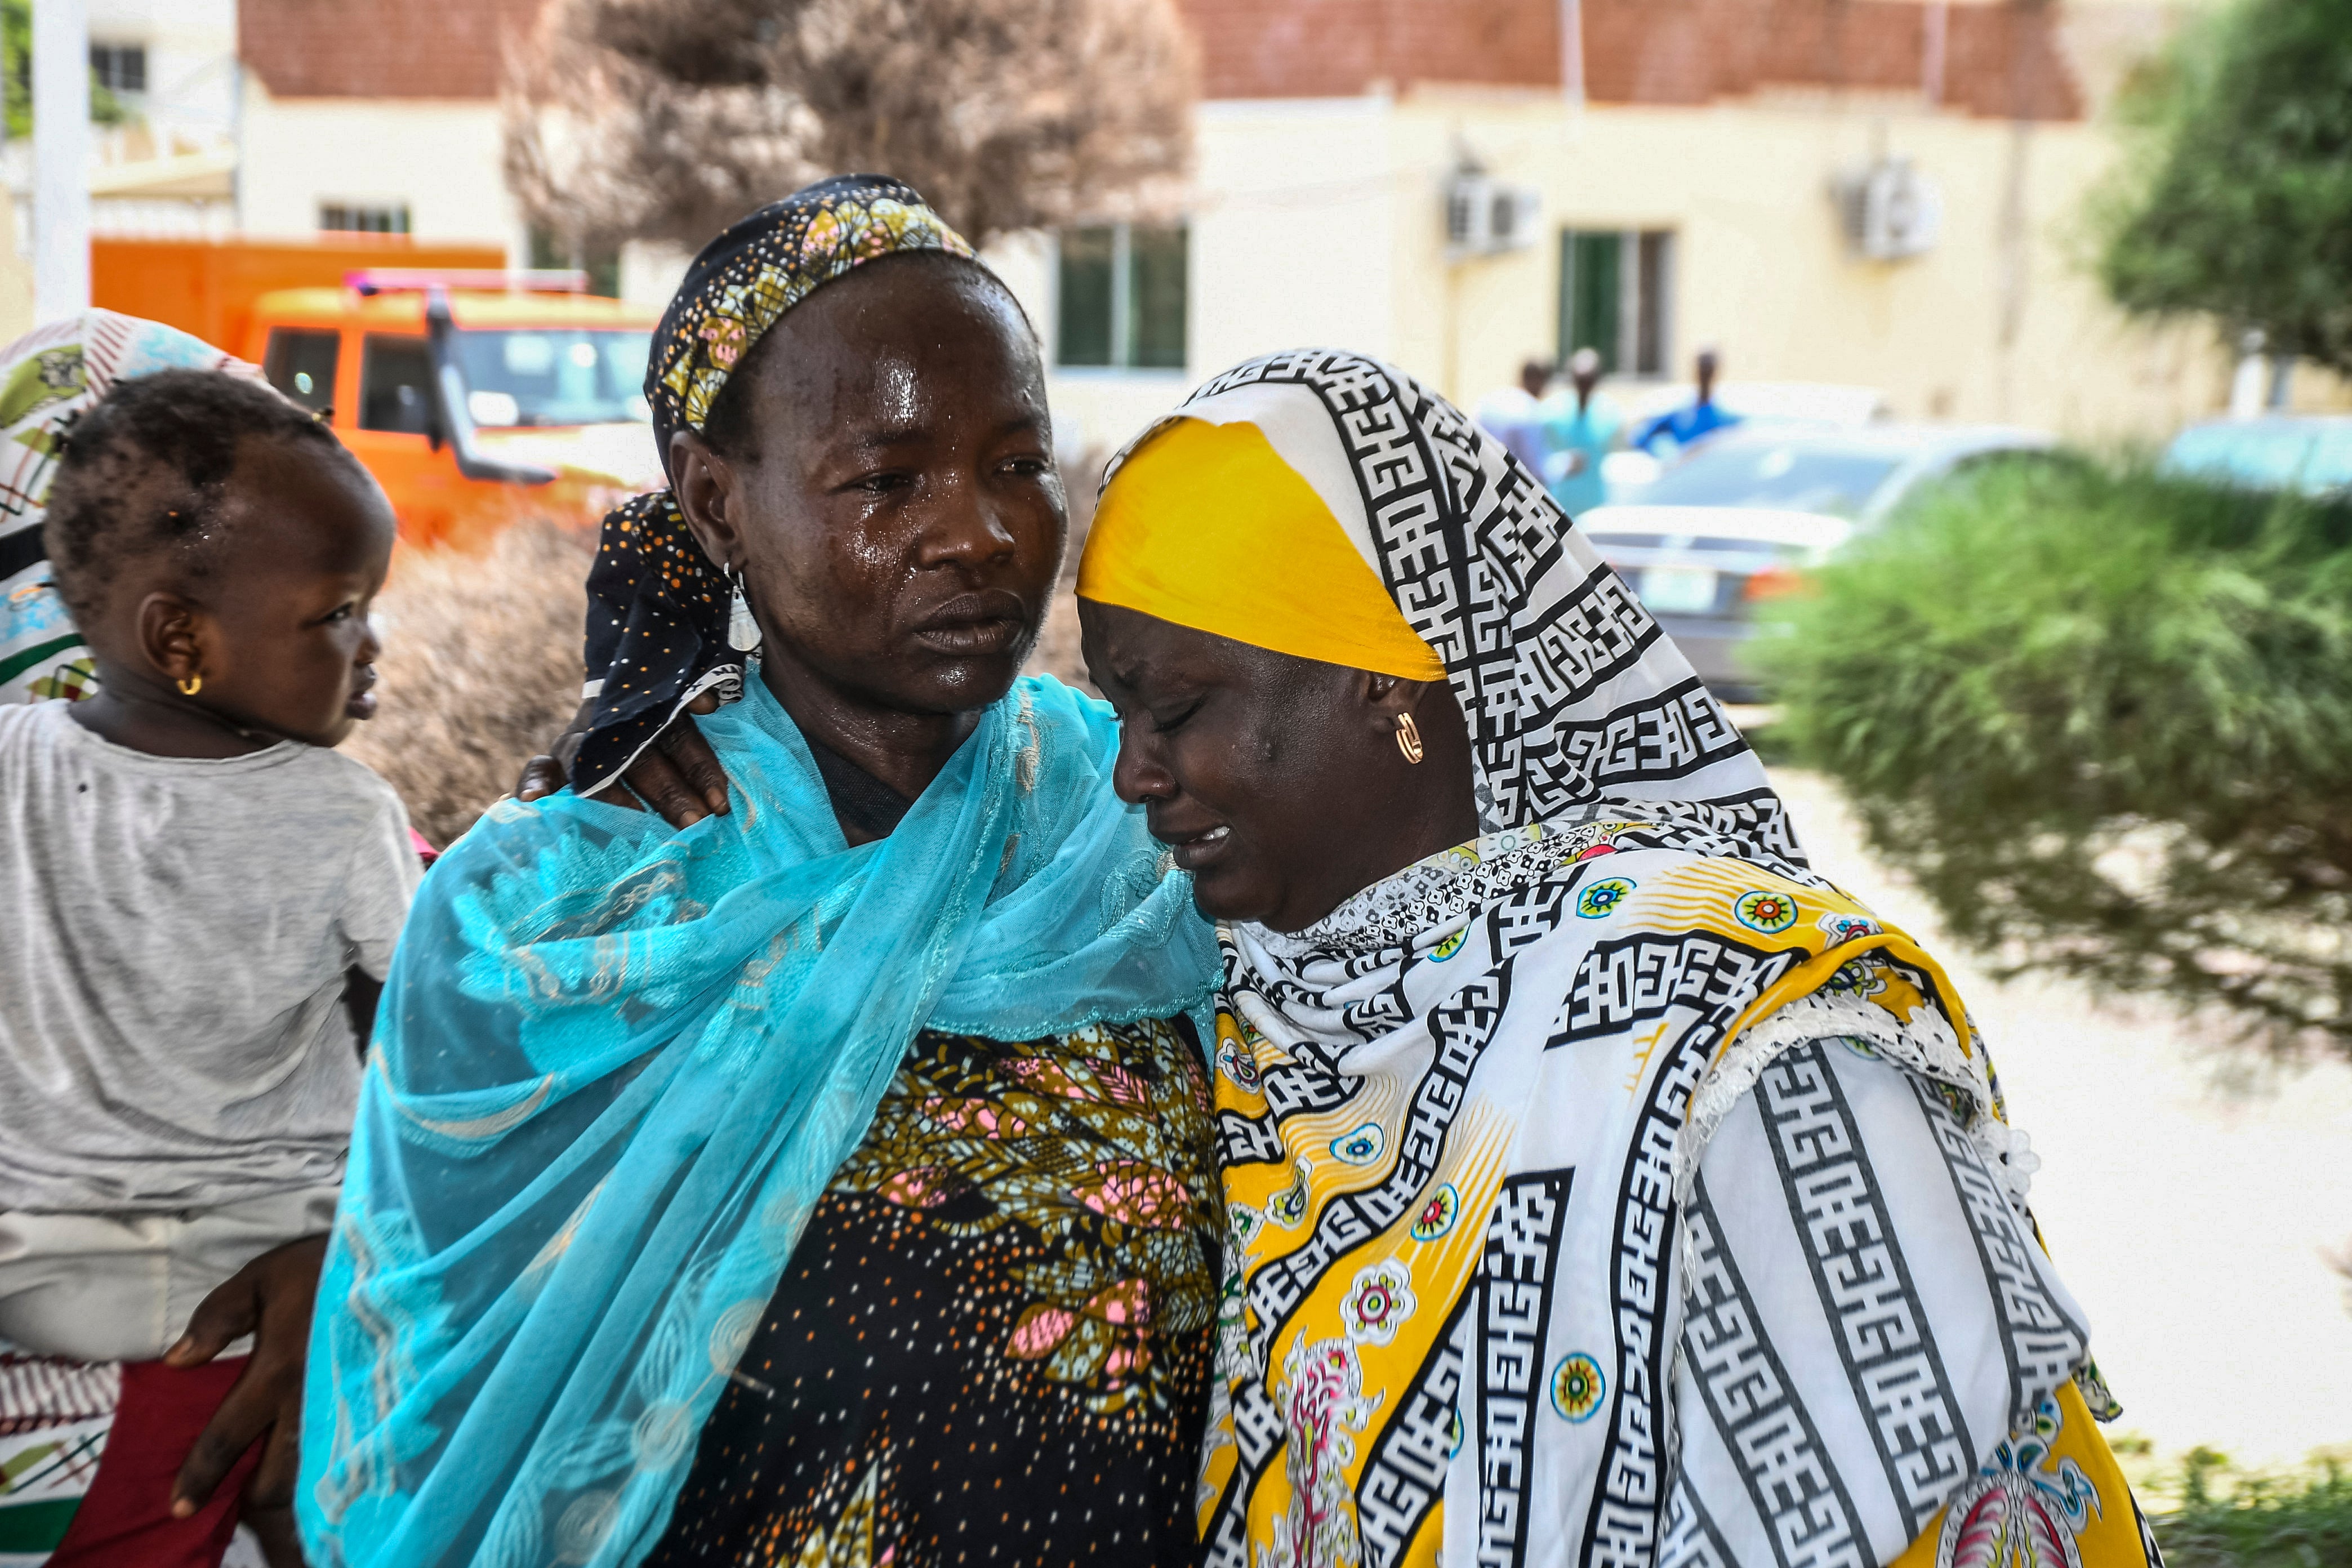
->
[649,1023,1223,1568]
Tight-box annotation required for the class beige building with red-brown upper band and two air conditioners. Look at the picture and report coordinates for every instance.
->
[1000,0,2342,461]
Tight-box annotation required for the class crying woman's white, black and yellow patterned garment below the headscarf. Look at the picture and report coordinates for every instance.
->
[1200,818,2142,1568]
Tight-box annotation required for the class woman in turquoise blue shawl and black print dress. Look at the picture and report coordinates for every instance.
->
[296,176,1223,1568]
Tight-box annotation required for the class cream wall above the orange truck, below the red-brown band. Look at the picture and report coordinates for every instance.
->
[238,73,529,263]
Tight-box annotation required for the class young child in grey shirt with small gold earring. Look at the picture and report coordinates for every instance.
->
[0,369,418,1568]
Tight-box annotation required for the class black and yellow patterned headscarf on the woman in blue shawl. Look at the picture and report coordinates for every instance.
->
[572,174,972,795]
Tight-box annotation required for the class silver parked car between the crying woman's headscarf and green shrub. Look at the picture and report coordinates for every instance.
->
[1576,425,2051,703]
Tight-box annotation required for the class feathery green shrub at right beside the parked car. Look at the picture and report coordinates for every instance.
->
[1754,458,2352,1051]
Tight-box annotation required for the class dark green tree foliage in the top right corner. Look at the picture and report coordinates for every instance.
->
[2098,0,2352,374]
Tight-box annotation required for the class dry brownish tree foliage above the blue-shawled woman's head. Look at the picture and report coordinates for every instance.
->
[506,0,1195,247]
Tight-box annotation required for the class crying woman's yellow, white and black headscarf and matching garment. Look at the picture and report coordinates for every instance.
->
[1080,350,2150,1568]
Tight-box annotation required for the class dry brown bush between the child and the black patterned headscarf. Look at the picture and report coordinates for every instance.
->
[344,522,595,847]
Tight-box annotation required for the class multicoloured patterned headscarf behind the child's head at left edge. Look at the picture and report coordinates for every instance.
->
[0,310,261,703]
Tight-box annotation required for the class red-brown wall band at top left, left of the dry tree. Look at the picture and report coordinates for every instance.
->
[238,0,541,99]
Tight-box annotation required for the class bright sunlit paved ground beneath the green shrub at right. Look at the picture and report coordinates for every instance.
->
[1774,769,2352,1462]
